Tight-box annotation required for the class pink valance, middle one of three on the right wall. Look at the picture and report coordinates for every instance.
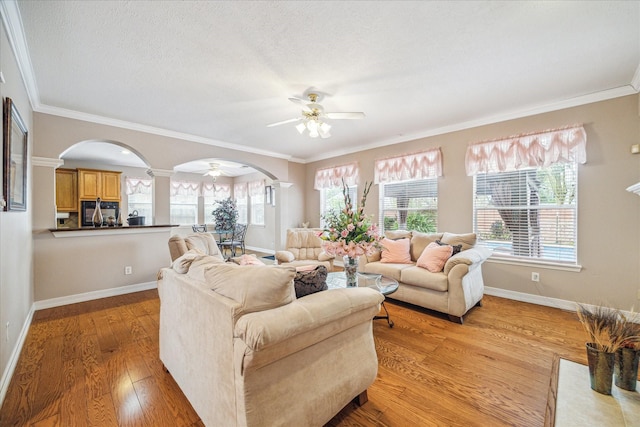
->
[373,148,442,184]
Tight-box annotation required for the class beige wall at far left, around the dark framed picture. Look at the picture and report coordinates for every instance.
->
[0,20,34,387]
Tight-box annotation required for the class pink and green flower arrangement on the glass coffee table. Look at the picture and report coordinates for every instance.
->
[318,179,381,258]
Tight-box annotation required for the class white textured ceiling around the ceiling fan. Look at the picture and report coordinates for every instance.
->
[8,1,640,161]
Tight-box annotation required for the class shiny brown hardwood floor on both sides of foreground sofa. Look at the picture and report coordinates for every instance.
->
[0,290,586,427]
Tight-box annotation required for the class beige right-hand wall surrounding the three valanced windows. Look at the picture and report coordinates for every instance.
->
[305,95,640,310]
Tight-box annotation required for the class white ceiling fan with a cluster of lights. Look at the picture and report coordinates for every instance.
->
[267,93,365,138]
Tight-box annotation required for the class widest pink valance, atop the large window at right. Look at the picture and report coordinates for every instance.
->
[465,125,587,176]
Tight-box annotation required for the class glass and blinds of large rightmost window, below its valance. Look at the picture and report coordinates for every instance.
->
[473,166,578,263]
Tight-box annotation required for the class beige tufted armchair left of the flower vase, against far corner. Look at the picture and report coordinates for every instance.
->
[275,228,335,271]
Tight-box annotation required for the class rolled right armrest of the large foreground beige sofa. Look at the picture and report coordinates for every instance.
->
[234,288,384,351]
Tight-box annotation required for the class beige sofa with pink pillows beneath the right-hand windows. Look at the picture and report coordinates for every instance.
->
[359,231,491,323]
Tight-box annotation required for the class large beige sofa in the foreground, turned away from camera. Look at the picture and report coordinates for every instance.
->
[158,233,383,426]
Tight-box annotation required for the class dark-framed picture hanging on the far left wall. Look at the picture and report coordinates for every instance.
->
[2,98,27,211]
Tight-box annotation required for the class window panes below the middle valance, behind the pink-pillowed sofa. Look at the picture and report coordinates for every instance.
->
[380,178,438,233]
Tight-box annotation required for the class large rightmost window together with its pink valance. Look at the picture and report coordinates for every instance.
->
[466,126,586,264]
